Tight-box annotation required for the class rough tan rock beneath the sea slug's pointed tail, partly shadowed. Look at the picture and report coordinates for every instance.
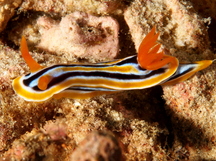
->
[163,64,216,160]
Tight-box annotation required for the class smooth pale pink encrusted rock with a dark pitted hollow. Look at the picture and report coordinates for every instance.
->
[37,12,119,60]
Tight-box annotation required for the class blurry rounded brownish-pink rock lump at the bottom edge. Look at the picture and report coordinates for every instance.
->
[71,132,122,161]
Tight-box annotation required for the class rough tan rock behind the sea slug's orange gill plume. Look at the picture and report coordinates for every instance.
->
[124,0,211,61]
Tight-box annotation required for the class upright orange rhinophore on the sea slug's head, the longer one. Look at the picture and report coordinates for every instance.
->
[20,36,43,72]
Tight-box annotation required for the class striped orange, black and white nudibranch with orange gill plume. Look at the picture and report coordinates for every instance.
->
[12,27,213,102]
